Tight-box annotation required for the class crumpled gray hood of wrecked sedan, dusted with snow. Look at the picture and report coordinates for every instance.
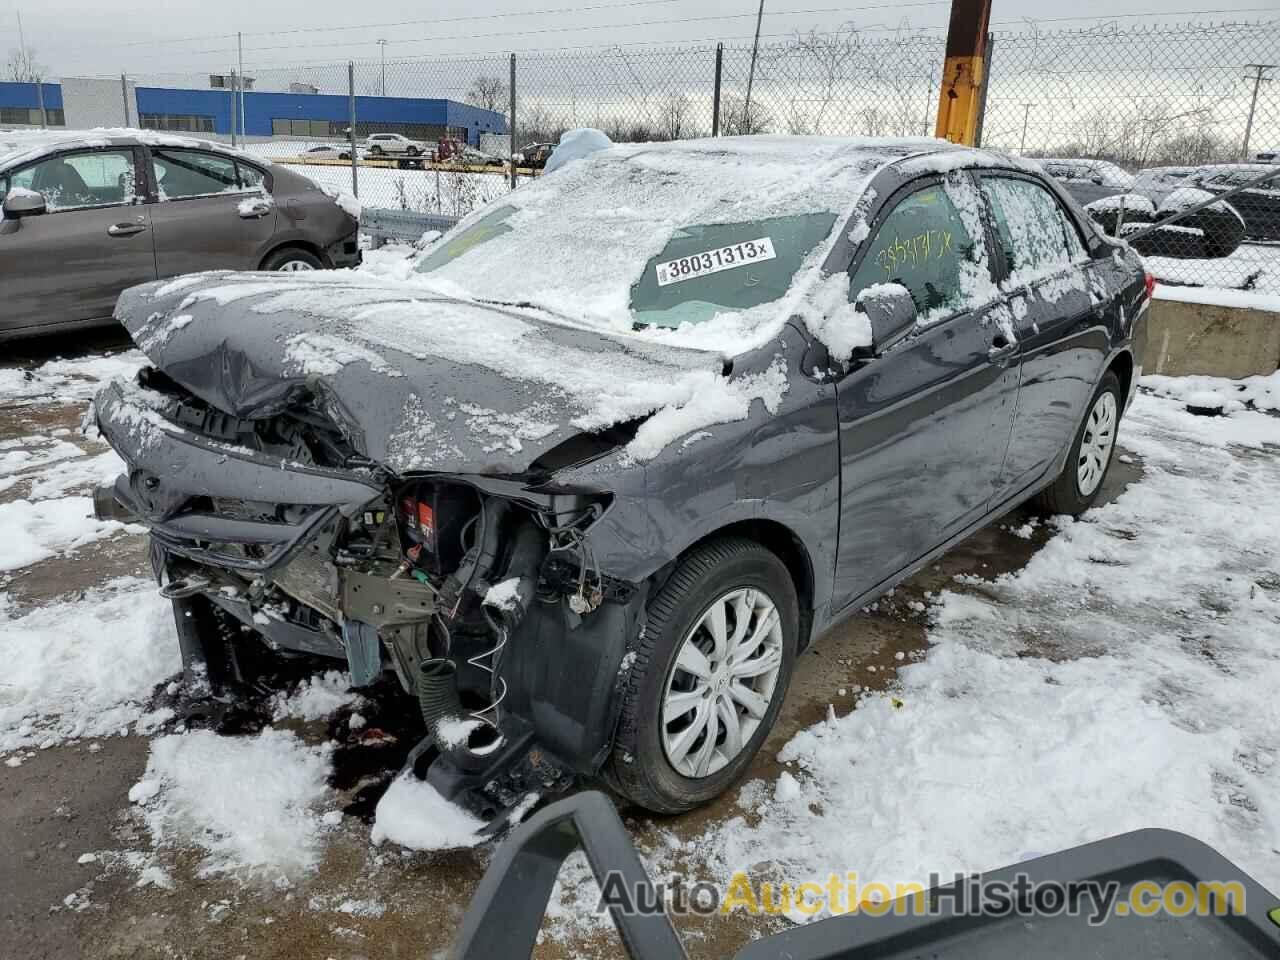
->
[116,273,723,474]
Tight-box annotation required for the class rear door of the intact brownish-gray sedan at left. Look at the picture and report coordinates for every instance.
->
[150,147,276,276]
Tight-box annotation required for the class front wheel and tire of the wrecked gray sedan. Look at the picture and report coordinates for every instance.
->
[605,538,799,813]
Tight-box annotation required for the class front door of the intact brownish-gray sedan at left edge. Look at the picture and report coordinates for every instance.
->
[0,147,156,329]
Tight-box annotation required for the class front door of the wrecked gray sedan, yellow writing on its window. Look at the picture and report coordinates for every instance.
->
[833,174,1018,609]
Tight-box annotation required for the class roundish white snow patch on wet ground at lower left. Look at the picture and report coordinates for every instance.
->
[129,727,330,882]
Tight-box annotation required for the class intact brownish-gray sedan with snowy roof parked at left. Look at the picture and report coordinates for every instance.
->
[0,132,360,339]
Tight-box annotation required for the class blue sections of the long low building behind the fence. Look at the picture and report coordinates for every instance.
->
[0,83,507,145]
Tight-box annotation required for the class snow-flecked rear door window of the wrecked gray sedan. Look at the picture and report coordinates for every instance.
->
[982,177,1084,283]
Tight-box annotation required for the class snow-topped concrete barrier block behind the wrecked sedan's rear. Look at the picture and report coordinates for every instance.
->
[1143,287,1280,380]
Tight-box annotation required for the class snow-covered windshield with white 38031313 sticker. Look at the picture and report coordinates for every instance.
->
[417,138,906,337]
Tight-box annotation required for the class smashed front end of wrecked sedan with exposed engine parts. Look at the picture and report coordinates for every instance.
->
[95,367,644,827]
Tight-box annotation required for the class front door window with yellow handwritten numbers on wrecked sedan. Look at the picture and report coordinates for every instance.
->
[849,175,991,324]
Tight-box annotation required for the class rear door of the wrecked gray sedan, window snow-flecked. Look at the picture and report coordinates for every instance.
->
[980,172,1112,499]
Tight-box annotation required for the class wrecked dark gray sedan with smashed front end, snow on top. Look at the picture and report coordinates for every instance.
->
[96,137,1149,822]
